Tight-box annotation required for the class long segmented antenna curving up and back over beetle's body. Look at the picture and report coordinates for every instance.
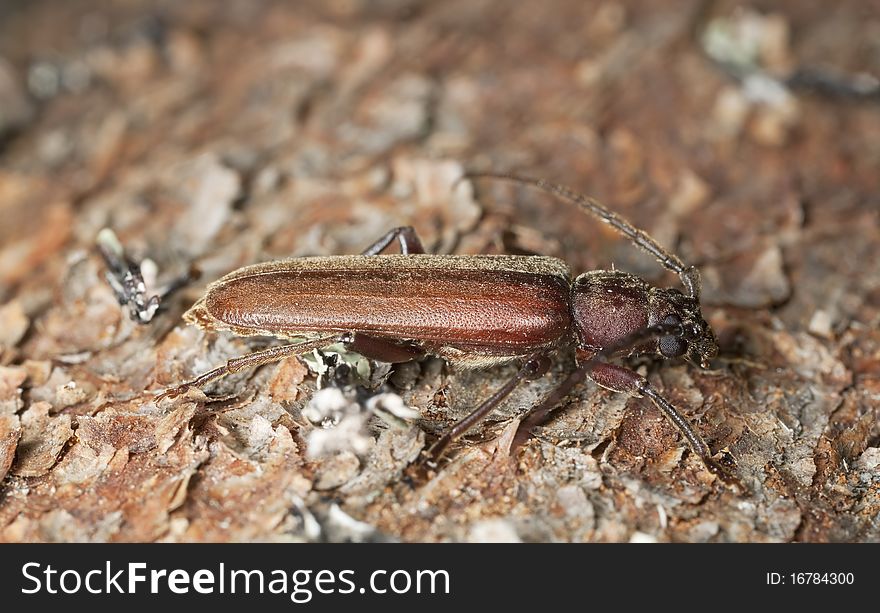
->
[462,172,701,301]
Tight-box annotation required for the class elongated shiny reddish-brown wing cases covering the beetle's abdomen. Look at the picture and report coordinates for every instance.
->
[194,255,570,355]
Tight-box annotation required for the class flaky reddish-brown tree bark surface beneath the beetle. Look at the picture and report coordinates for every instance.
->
[0,0,880,541]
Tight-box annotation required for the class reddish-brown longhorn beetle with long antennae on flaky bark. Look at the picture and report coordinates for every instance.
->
[160,173,736,483]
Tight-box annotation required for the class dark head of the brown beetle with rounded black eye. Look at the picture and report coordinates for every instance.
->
[650,288,718,368]
